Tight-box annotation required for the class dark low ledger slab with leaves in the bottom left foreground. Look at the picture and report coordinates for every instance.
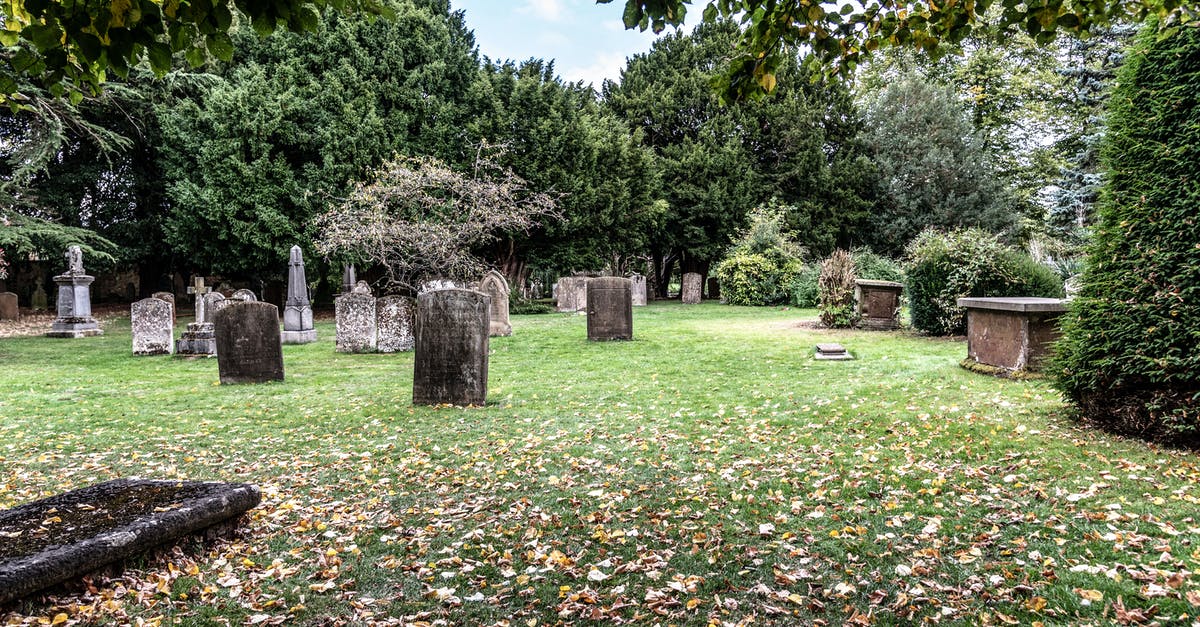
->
[0,479,262,605]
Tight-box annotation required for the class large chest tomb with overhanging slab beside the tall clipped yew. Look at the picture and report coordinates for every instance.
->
[958,297,1067,374]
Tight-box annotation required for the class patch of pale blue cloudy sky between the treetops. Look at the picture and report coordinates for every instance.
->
[450,0,671,90]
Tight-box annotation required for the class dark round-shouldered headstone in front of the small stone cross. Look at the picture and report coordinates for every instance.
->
[212,300,283,384]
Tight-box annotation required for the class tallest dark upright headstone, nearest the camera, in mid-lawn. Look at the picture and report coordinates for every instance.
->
[413,289,491,405]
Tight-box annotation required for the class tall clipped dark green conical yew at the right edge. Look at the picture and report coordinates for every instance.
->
[1052,25,1200,447]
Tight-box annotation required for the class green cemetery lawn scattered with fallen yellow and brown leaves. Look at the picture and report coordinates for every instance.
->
[0,304,1200,625]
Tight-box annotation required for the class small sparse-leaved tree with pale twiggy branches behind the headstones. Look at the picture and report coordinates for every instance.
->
[317,147,560,292]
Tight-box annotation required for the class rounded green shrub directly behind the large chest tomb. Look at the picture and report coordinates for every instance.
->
[905,228,1062,335]
